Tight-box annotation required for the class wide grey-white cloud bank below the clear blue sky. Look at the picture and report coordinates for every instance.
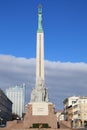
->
[0,55,87,109]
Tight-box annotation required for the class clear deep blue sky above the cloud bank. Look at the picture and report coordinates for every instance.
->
[0,0,87,62]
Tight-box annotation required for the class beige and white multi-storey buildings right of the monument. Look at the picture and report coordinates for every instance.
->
[63,96,87,127]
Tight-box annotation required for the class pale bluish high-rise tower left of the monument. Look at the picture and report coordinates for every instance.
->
[6,84,25,117]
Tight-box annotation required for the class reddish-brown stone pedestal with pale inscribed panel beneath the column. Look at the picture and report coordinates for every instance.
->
[24,102,57,128]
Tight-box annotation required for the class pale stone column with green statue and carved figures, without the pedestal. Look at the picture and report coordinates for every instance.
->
[31,5,48,102]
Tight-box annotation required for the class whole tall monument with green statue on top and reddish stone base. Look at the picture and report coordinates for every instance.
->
[24,5,57,129]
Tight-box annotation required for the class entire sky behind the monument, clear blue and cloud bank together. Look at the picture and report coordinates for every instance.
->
[0,0,87,109]
